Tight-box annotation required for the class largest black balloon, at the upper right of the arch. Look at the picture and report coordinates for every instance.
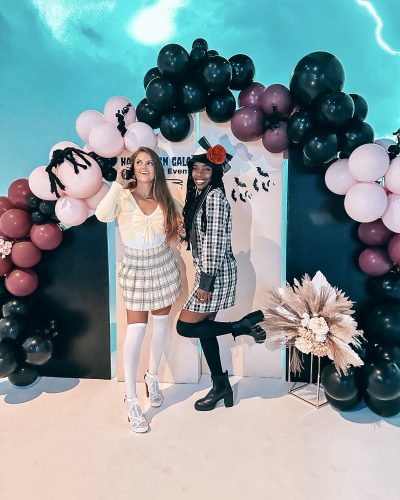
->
[290,52,345,106]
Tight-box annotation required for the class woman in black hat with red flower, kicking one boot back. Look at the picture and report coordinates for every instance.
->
[177,137,266,411]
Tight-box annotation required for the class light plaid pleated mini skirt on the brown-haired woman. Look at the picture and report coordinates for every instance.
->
[118,243,182,311]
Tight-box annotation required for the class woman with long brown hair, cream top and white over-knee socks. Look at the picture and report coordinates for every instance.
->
[96,147,181,432]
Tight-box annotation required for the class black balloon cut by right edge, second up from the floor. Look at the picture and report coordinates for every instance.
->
[365,362,400,401]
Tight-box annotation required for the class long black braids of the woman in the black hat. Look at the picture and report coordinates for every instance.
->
[182,161,225,243]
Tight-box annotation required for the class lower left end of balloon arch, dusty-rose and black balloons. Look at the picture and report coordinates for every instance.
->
[0,179,62,386]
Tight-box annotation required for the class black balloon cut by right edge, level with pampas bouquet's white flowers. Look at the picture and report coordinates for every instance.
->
[364,304,400,346]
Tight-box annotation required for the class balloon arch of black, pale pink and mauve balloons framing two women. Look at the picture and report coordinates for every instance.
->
[0,39,400,416]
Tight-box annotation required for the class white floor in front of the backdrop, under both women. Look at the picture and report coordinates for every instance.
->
[0,376,400,500]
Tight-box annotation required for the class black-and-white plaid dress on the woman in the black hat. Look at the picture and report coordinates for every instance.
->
[183,188,237,312]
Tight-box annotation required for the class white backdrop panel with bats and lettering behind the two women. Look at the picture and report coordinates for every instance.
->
[116,113,283,383]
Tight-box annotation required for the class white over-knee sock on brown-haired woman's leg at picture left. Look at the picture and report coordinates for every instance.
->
[124,323,147,399]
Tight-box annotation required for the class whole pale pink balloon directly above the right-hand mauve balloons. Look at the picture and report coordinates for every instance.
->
[344,182,388,222]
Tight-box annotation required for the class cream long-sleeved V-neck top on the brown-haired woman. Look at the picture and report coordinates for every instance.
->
[95,182,181,249]
